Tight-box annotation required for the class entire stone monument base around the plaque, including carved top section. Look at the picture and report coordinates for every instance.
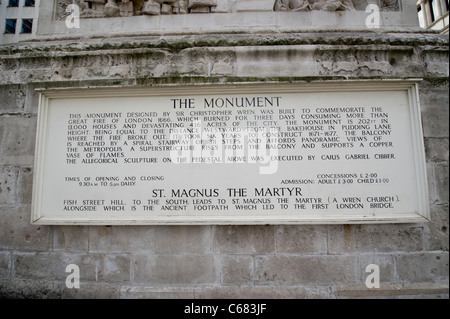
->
[0,0,449,299]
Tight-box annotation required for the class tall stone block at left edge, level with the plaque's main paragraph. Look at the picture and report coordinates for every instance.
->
[0,114,37,166]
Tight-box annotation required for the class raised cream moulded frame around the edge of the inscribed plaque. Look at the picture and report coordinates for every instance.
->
[31,79,430,225]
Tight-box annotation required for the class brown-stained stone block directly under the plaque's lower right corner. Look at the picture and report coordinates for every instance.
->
[328,224,423,254]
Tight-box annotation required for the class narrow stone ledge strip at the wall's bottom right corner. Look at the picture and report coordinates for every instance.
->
[336,282,449,298]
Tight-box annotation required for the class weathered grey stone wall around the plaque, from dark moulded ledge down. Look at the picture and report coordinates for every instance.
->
[0,31,449,298]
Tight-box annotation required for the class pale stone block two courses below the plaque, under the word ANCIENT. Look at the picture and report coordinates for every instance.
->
[133,254,216,286]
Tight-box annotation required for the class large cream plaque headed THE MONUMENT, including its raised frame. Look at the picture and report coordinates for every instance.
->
[32,81,429,225]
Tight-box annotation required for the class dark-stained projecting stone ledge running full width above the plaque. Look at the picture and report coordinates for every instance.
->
[0,30,449,59]
